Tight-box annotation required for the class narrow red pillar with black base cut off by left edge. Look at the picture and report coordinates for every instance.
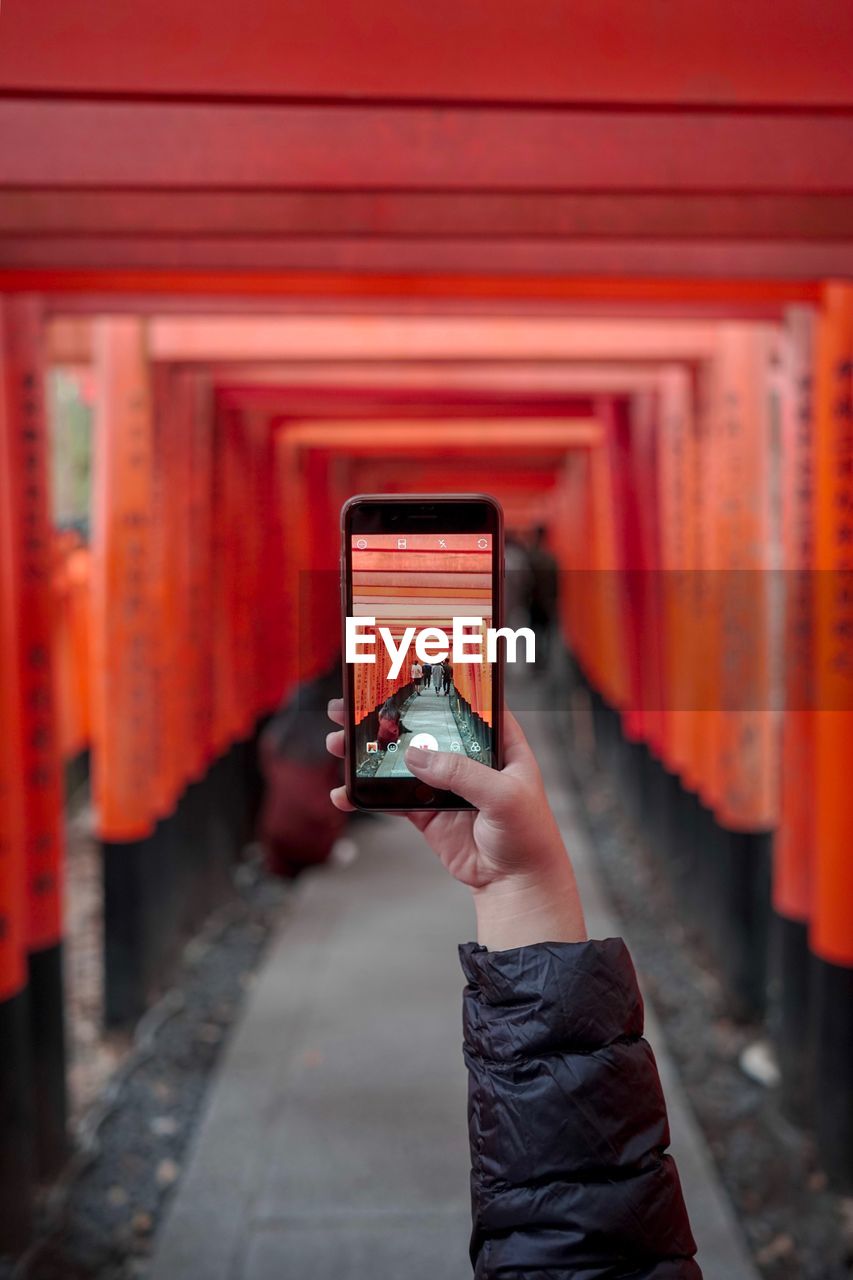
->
[0,302,35,1239]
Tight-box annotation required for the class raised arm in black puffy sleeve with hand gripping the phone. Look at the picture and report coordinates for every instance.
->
[329,703,701,1280]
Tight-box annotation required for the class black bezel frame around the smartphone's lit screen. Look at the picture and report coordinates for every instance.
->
[341,493,503,813]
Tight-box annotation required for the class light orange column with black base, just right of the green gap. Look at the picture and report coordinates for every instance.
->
[92,316,163,1023]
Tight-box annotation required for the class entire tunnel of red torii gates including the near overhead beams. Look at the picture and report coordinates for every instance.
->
[0,0,853,1249]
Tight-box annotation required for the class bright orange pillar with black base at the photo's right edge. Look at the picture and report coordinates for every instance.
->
[809,284,853,1189]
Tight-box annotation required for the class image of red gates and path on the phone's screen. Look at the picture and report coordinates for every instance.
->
[352,534,494,778]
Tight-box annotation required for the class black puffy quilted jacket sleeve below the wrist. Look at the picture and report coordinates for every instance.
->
[460,938,701,1280]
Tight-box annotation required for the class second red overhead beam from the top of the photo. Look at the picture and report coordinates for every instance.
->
[0,97,853,195]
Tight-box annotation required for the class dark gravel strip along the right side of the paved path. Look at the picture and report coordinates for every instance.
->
[563,732,853,1280]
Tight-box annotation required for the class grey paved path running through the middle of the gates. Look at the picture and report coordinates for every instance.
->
[151,713,757,1280]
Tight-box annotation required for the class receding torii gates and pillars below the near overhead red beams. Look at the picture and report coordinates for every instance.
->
[0,293,853,1239]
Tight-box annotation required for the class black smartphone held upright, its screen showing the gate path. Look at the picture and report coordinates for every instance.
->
[341,494,503,810]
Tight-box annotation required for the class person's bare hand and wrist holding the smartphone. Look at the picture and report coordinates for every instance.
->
[327,698,587,950]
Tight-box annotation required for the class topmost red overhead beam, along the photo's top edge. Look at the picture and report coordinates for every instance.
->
[0,0,853,105]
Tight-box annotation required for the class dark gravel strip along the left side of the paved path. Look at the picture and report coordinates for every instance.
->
[0,849,288,1280]
